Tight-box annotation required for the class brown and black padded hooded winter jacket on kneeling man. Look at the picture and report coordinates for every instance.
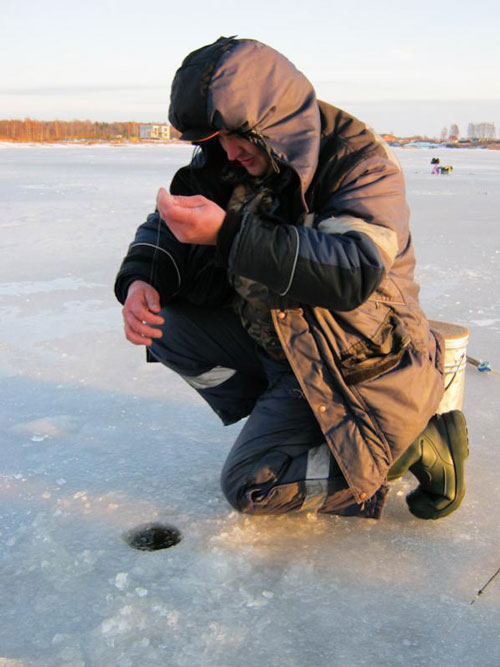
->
[115,38,443,516]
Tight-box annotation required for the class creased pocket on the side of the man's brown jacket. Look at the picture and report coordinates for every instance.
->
[340,312,410,385]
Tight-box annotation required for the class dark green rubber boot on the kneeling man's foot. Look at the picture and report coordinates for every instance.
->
[387,410,469,519]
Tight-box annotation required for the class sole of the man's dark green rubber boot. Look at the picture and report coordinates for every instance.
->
[406,411,469,520]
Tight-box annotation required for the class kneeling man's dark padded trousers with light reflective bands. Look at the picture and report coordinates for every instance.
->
[150,302,352,514]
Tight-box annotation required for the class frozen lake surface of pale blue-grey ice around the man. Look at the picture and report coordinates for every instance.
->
[0,144,500,667]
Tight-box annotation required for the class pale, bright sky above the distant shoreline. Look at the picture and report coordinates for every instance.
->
[0,0,500,136]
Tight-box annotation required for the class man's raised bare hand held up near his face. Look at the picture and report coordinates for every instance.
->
[156,188,226,245]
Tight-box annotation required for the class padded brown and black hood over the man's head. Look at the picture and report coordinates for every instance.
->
[169,37,321,194]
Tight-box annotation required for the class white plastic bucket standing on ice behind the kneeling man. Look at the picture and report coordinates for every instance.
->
[429,320,470,414]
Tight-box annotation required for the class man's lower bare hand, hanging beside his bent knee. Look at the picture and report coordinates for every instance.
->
[122,280,164,345]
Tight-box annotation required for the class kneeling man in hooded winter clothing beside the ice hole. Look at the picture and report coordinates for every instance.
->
[115,38,468,519]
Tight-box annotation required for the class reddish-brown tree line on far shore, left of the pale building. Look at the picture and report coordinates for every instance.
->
[0,118,139,141]
